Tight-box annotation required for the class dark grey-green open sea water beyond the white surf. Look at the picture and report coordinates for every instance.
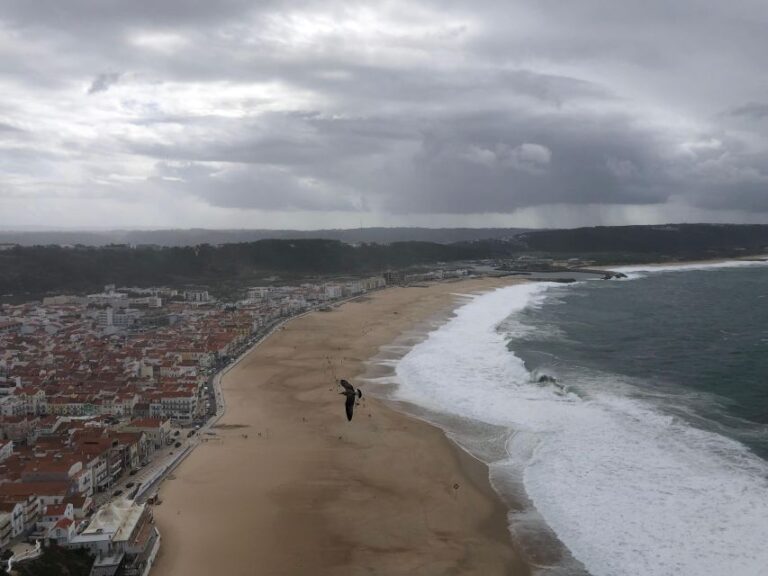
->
[509,266,768,458]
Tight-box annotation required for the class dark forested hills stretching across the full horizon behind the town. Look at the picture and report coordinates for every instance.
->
[0,224,768,299]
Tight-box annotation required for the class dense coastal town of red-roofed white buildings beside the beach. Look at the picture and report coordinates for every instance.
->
[0,270,426,575]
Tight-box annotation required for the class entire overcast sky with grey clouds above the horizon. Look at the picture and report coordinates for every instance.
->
[0,0,768,229]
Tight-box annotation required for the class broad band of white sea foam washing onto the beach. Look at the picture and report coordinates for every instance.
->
[395,284,768,576]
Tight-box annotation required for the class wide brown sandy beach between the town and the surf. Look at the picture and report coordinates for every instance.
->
[152,279,529,576]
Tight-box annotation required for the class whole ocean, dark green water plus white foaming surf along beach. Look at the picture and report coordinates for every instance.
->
[379,263,768,576]
